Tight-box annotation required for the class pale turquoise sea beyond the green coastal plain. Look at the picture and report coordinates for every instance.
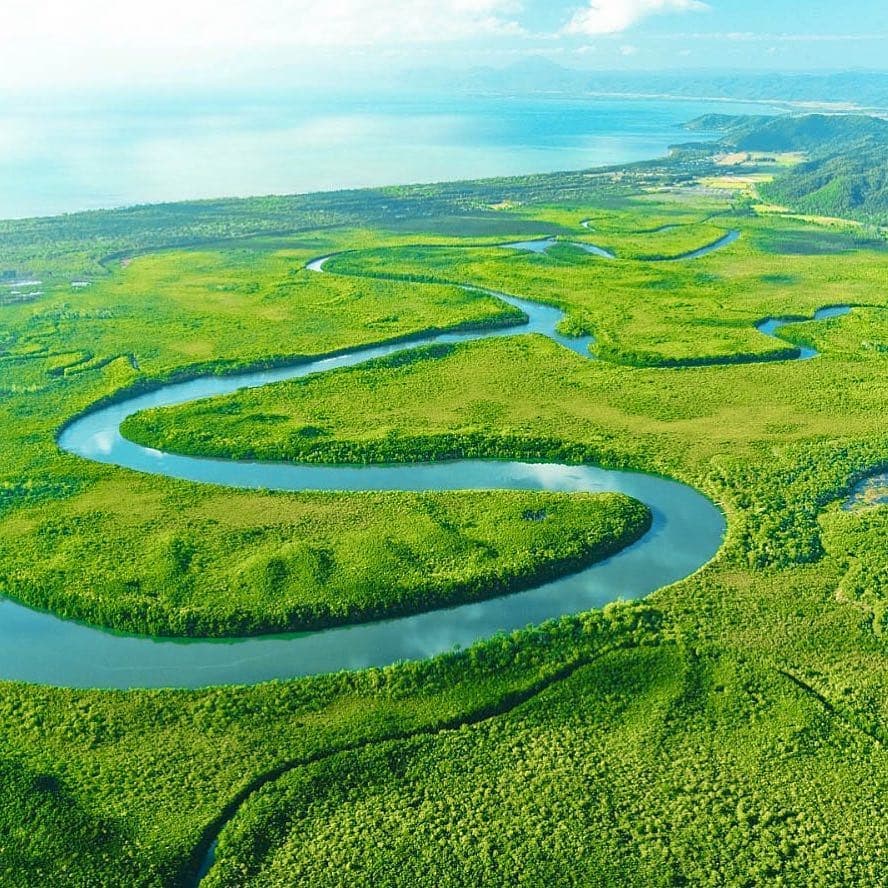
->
[0,91,762,218]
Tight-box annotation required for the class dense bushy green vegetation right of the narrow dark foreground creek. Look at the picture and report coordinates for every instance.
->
[207,645,888,888]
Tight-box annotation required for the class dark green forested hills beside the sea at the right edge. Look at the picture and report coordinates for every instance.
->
[688,114,888,224]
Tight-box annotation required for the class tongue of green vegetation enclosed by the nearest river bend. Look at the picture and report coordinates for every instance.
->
[0,479,650,637]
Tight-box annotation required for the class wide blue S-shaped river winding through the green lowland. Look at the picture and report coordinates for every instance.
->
[0,229,856,688]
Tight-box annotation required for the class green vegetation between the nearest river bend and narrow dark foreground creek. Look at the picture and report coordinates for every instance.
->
[0,606,658,886]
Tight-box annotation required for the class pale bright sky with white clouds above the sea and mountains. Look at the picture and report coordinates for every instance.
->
[0,0,888,93]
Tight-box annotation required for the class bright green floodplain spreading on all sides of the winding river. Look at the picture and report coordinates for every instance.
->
[0,128,888,886]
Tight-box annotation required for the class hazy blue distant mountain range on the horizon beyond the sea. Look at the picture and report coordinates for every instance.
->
[410,58,888,112]
